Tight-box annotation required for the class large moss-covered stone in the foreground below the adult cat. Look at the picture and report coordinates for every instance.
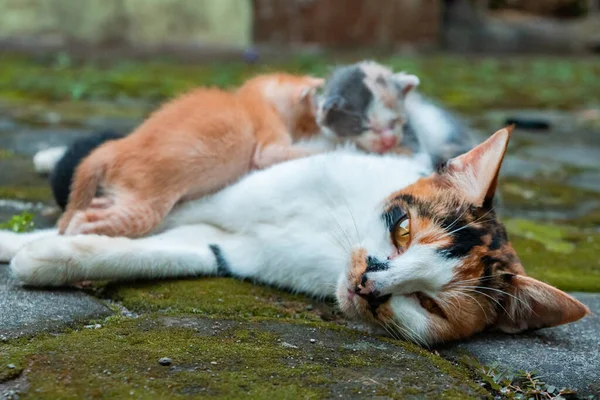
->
[0,317,487,399]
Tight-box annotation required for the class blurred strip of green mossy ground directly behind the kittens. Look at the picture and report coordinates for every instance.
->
[0,53,600,112]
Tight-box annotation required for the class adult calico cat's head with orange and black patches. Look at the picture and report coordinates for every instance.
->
[337,128,589,345]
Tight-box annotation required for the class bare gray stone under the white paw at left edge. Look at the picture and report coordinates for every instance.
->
[0,264,111,338]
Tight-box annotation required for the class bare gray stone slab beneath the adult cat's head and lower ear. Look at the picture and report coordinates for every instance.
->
[440,293,600,396]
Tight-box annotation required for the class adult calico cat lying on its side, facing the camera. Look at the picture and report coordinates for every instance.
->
[0,129,589,346]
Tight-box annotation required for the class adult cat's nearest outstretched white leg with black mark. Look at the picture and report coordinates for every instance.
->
[11,225,262,286]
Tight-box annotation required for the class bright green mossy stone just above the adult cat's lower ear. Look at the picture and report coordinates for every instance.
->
[505,220,600,292]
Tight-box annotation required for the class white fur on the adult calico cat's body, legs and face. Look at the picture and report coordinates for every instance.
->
[0,149,454,343]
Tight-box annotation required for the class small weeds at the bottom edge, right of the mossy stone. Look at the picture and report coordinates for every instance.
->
[472,364,595,400]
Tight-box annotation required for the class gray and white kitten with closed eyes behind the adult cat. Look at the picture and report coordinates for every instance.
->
[317,61,472,166]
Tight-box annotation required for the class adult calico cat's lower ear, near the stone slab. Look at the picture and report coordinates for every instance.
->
[495,275,590,333]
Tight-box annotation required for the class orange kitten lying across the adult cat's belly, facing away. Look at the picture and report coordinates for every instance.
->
[58,74,323,237]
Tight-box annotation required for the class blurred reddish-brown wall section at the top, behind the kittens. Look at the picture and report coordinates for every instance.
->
[252,0,441,46]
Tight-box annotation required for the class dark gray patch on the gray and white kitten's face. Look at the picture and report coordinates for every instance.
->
[322,65,373,137]
